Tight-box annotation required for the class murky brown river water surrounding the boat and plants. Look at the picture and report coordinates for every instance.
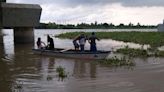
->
[0,29,164,92]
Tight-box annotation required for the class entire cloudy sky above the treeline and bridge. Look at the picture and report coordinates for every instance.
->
[7,0,164,25]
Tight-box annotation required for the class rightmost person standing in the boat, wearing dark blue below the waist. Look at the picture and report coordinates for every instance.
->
[88,32,100,52]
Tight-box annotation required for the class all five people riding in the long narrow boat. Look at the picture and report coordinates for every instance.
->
[37,32,100,52]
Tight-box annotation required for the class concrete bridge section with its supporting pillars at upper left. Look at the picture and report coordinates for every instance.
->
[0,0,42,43]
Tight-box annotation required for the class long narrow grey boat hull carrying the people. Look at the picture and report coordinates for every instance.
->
[33,49,110,59]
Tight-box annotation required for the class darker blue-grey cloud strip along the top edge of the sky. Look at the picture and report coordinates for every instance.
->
[7,0,164,7]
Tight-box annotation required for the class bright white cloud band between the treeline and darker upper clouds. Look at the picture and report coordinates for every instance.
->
[41,4,164,24]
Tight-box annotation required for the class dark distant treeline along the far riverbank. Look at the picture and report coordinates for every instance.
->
[36,22,157,29]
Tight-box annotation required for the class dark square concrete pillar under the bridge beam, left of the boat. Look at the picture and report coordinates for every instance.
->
[14,27,34,44]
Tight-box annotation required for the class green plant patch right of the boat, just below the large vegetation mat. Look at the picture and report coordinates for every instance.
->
[116,48,149,57]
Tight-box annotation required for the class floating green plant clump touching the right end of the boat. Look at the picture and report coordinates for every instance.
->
[98,57,135,66]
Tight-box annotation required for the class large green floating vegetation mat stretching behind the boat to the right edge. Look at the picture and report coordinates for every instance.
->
[56,32,164,48]
